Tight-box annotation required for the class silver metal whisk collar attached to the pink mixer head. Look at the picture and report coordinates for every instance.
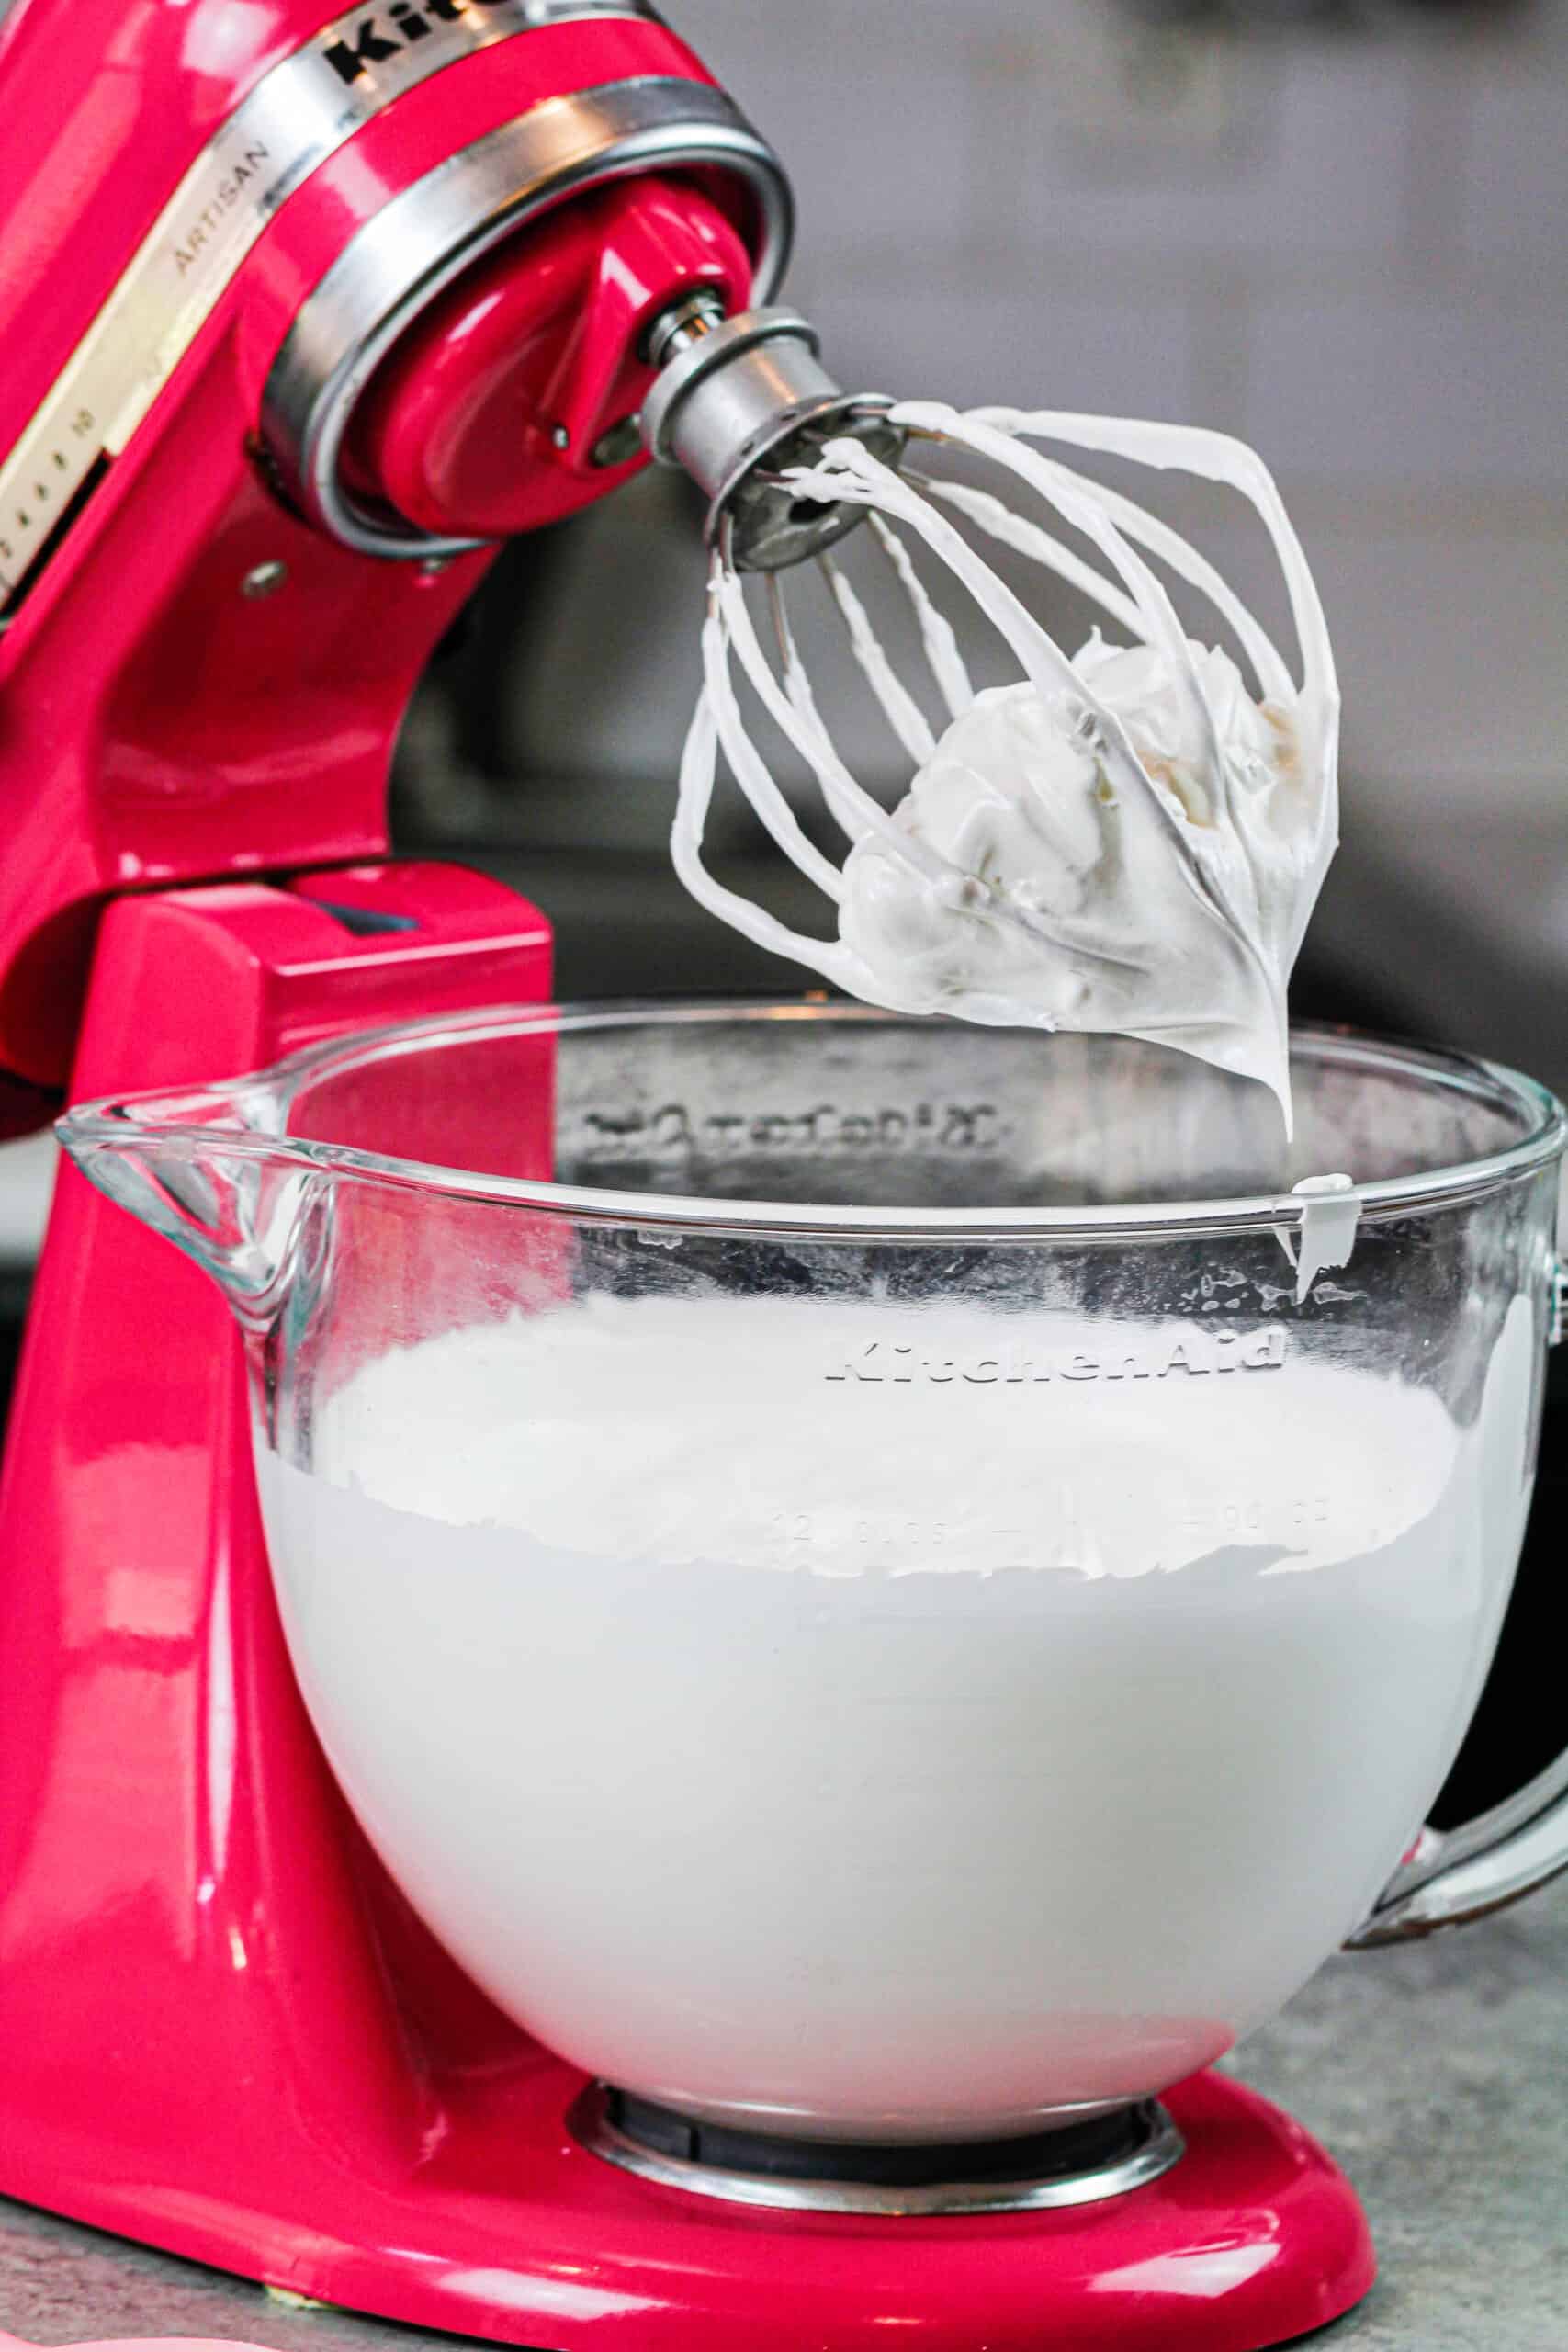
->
[642,294,905,571]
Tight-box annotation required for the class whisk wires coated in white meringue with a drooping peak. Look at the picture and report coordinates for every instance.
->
[674,402,1340,1125]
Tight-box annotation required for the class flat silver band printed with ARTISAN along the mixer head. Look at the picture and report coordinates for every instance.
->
[0,0,660,602]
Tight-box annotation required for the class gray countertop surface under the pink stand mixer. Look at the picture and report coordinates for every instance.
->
[0,1882,1568,2352]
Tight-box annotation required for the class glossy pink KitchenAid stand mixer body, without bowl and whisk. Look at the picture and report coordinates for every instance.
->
[0,0,1568,2352]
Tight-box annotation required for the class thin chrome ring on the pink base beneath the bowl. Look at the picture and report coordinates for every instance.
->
[581,2084,1187,2218]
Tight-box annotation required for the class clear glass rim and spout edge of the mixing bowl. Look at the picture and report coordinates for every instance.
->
[56,995,1568,1242]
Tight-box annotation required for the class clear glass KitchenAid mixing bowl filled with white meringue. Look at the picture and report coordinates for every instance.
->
[63,1002,1568,2143]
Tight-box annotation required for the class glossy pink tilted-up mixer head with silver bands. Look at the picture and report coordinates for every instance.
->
[0,0,898,1091]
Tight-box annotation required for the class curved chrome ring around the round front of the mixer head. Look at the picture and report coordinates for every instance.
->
[261,75,795,560]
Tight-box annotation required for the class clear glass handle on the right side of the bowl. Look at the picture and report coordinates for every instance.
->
[1345,1263,1568,1952]
